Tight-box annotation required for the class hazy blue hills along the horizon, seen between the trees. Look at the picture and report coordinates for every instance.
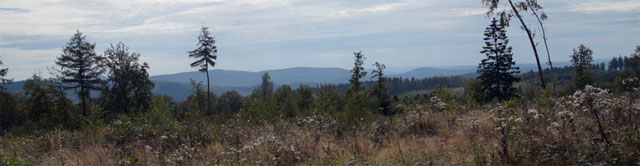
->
[6,59,609,101]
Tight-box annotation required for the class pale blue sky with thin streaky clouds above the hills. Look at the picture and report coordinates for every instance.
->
[0,0,640,80]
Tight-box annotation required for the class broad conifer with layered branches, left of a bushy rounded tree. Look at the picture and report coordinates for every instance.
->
[56,30,104,117]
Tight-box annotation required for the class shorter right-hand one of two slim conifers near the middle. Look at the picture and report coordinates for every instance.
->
[371,62,391,116]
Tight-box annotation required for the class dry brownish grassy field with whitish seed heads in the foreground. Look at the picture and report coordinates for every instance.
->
[0,86,640,165]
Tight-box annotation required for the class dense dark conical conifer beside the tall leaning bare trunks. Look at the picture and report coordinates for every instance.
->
[478,18,520,100]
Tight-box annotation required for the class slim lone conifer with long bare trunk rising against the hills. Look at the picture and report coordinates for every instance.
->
[189,26,218,113]
